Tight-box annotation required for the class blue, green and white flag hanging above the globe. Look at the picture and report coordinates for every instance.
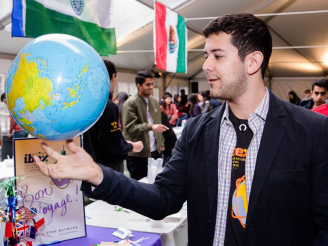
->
[12,0,117,56]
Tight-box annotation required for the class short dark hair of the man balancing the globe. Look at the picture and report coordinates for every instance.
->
[203,13,272,78]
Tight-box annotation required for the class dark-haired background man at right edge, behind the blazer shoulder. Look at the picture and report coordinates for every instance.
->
[300,79,328,109]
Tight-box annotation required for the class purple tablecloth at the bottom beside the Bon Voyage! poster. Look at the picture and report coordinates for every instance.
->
[56,226,162,246]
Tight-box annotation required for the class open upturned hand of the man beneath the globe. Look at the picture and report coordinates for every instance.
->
[34,140,103,186]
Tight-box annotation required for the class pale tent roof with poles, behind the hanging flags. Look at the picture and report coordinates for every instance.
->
[0,0,328,80]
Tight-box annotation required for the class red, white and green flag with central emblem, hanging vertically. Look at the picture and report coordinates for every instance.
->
[154,2,187,73]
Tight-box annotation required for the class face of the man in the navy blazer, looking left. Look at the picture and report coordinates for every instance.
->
[203,32,248,101]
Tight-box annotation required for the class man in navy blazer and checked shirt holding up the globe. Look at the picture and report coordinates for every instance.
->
[35,14,328,246]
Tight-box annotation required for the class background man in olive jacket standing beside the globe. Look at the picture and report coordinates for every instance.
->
[122,71,168,180]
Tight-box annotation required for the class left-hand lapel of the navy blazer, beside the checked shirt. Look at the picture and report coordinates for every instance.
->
[205,104,225,224]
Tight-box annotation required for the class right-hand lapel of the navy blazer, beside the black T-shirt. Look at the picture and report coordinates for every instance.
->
[246,92,286,225]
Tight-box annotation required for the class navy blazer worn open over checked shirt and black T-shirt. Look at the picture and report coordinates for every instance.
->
[82,92,328,246]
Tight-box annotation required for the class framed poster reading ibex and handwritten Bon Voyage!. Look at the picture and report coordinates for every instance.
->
[14,137,86,245]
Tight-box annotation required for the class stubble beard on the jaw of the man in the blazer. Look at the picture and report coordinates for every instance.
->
[210,63,248,101]
